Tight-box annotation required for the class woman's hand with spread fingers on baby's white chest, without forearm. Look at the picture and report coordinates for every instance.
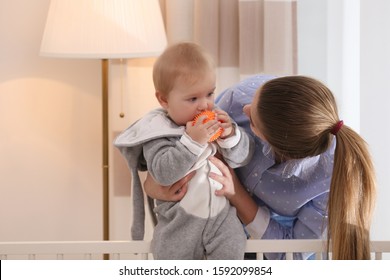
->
[209,157,236,200]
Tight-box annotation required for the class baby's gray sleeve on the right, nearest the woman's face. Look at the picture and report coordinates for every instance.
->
[218,126,255,168]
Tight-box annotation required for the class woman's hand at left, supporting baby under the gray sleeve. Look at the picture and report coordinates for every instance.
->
[144,171,195,202]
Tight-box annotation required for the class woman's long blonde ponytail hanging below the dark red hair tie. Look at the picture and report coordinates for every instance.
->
[328,126,375,260]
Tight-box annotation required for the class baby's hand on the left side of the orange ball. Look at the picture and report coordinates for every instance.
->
[186,116,220,145]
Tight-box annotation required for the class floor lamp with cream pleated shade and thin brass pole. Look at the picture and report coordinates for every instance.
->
[40,0,167,252]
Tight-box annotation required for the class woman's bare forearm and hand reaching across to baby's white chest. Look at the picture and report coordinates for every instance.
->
[209,157,258,225]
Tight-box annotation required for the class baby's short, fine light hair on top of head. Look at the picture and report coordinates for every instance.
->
[153,42,215,95]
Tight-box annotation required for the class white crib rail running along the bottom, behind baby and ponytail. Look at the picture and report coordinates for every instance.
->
[0,240,390,260]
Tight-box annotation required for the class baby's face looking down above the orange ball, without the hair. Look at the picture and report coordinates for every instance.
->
[165,71,216,125]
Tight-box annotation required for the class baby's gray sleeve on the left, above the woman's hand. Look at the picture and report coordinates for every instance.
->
[143,138,198,186]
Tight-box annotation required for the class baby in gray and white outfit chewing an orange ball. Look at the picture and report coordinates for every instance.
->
[115,42,254,259]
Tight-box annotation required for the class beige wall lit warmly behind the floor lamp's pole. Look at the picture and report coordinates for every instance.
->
[0,0,156,241]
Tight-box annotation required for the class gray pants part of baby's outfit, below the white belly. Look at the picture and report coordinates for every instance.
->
[152,202,246,260]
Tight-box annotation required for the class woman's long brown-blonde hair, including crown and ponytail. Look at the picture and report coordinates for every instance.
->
[255,76,376,260]
